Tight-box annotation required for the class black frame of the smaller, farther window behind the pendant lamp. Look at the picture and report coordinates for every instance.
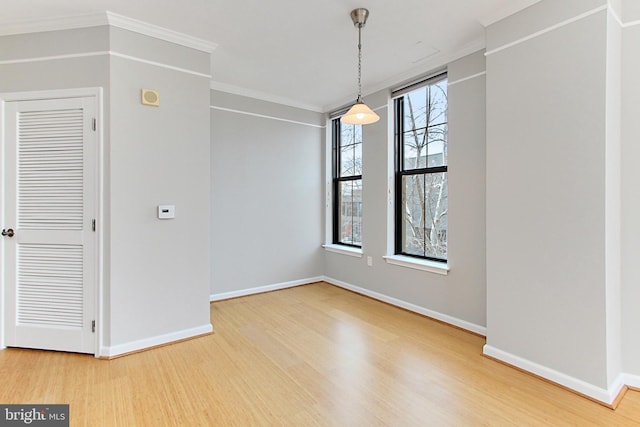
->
[331,117,362,249]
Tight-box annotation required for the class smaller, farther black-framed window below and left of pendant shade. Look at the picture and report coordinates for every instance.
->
[332,118,362,247]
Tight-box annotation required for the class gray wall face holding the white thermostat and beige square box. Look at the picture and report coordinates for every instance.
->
[107,28,210,347]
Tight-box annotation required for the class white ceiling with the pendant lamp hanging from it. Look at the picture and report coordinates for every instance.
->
[0,0,539,111]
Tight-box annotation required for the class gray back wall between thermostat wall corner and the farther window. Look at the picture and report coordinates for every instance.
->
[210,91,324,298]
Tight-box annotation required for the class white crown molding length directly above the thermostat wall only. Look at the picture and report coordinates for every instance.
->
[106,11,218,53]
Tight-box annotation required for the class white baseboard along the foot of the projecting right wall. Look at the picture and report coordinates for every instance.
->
[482,344,625,405]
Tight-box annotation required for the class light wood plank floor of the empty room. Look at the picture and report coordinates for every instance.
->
[0,283,640,427]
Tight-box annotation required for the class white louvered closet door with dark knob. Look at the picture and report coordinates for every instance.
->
[2,97,97,353]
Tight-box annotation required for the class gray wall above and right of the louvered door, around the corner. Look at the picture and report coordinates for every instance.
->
[0,26,215,355]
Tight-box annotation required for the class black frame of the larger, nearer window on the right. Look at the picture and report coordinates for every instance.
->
[392,71,449,264]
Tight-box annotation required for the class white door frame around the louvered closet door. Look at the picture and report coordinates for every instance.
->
[0,87,105,358]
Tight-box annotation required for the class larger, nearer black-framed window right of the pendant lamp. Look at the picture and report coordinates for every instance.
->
[394,74,448,261]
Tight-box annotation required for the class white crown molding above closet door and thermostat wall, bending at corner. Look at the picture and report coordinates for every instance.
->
[0,11,218,53]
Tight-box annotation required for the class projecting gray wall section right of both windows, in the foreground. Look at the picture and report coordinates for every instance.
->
[487,0,620,389]
